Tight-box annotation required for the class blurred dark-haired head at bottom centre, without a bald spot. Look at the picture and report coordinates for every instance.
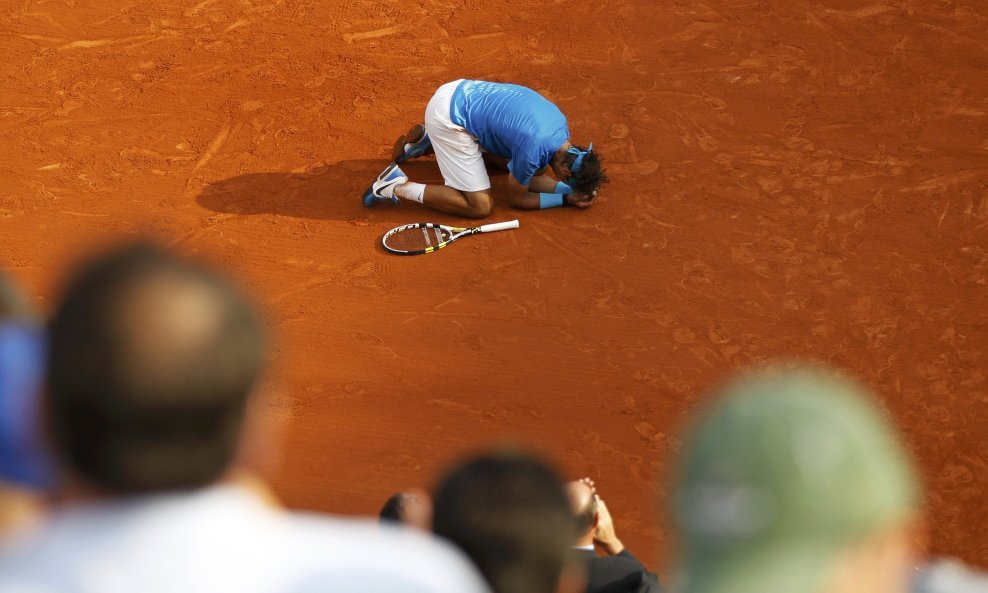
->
[433,452,577,593]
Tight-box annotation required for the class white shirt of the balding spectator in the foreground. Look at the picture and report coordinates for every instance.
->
[0,486,487,593]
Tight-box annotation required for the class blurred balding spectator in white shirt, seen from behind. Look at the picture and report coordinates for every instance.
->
[0,246,485,593]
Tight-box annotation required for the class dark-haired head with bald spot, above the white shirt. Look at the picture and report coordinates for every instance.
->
[47,244,264,494]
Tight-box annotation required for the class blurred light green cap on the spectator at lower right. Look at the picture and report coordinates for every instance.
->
[674,369,919,593]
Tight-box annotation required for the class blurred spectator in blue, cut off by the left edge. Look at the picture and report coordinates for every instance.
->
[0,274,53,534]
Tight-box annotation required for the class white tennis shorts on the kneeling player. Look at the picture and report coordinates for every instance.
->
[425,80,491,191]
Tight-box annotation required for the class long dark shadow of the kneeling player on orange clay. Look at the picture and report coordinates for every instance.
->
[196,159,442,222]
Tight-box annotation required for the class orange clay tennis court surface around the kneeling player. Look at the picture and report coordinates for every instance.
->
[0,0,988,568]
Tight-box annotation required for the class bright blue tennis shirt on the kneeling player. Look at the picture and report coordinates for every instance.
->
[449,80,569,185]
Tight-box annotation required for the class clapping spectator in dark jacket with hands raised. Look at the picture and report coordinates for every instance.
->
[566,478,662,593]
